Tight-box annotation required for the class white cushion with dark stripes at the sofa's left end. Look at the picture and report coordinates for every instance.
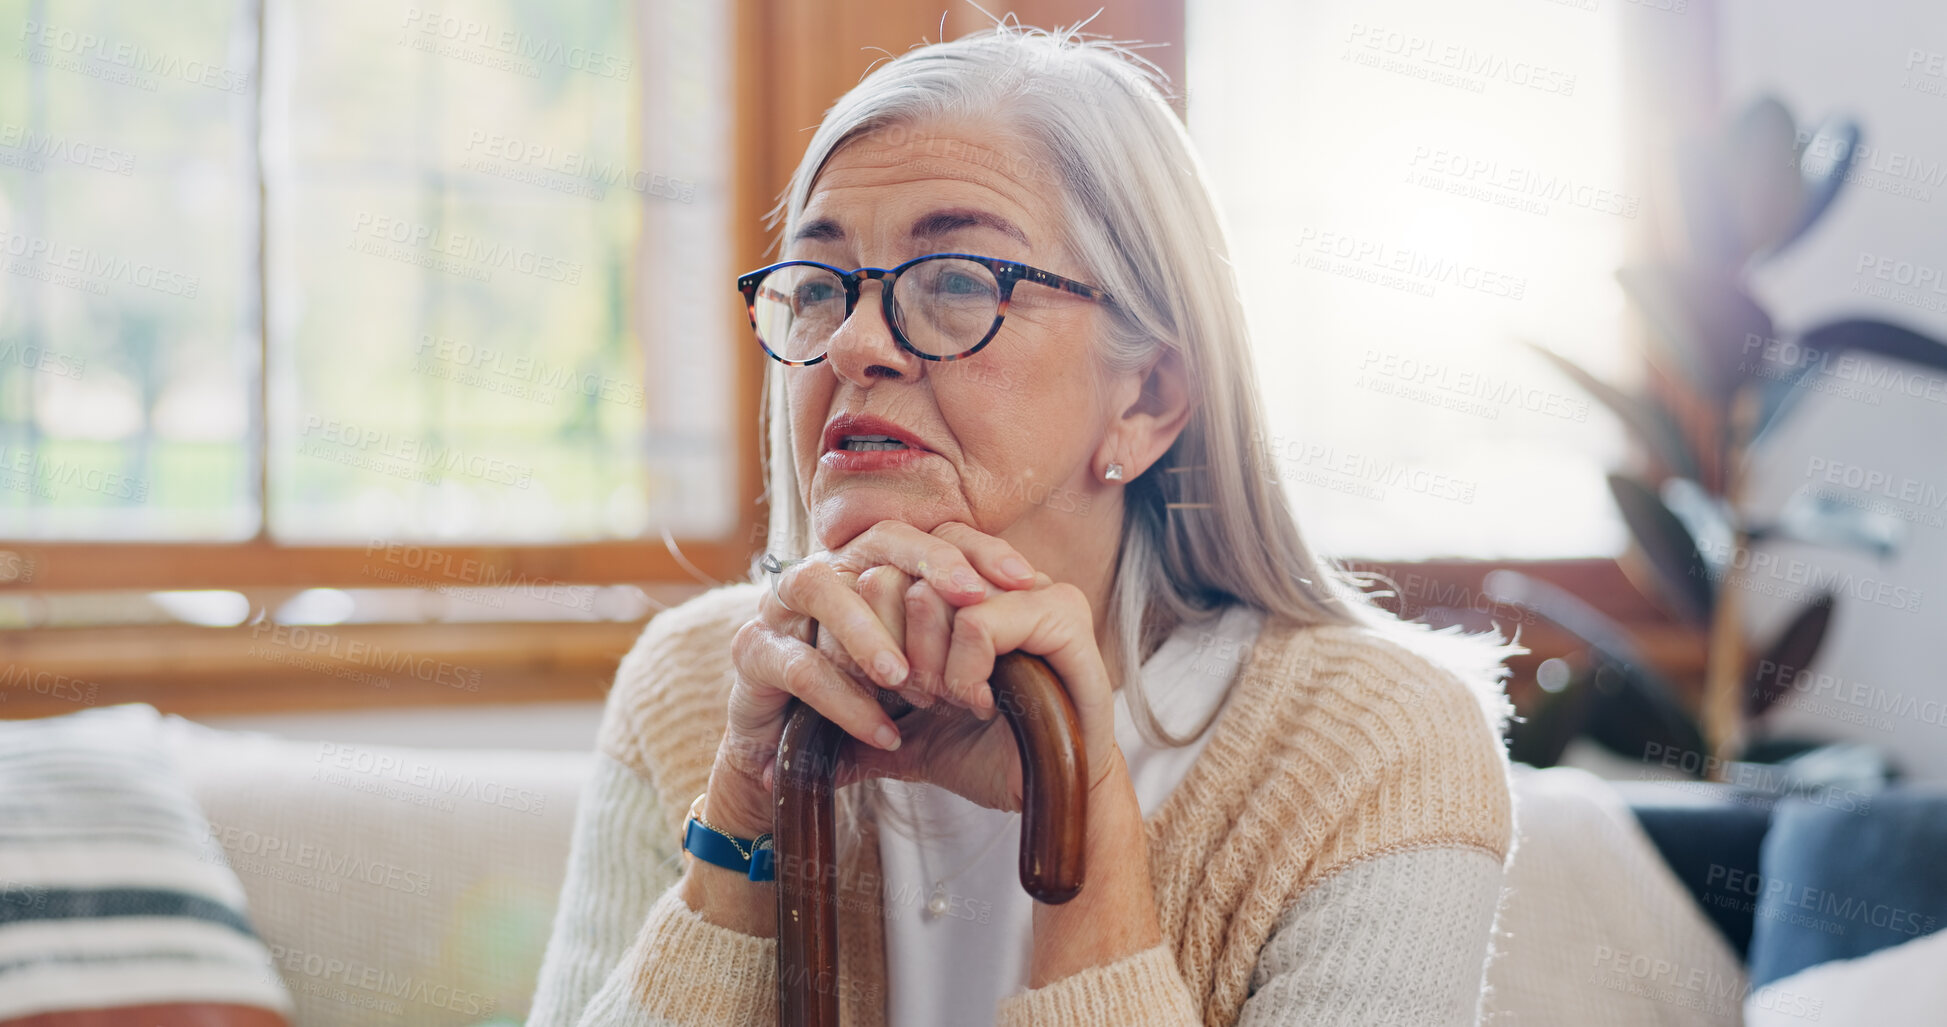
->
[0,704,292,1027]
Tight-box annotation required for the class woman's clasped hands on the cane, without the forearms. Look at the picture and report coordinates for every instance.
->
[711,520,1121,818]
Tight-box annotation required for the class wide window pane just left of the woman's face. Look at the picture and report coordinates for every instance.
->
[265,0,734,542]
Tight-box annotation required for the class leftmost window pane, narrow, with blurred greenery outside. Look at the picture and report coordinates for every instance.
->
[0,0,257,540]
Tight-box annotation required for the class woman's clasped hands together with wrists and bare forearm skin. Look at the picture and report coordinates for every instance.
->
[683,520,1162,988]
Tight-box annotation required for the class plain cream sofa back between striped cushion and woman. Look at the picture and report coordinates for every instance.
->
[164,717,590,1027]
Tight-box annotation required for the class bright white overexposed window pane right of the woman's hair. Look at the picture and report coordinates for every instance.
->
[1188,0,1645,559]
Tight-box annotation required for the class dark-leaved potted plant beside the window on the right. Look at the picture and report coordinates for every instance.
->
[1486,97,1947,778]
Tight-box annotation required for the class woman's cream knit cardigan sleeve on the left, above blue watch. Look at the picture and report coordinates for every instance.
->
[528,585,777,1027]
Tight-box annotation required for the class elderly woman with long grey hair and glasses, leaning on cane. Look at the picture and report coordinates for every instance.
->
[530,25,1511,1027]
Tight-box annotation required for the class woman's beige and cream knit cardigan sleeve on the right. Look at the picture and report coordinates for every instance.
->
[1236,635,1513,1027]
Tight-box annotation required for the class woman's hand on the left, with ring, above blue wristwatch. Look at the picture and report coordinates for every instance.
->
[703,520,1036,838]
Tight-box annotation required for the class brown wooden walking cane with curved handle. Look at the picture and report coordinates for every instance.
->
[771,653,1088,1027]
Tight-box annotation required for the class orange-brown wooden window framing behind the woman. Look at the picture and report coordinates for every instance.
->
[0,0,1702,717]
